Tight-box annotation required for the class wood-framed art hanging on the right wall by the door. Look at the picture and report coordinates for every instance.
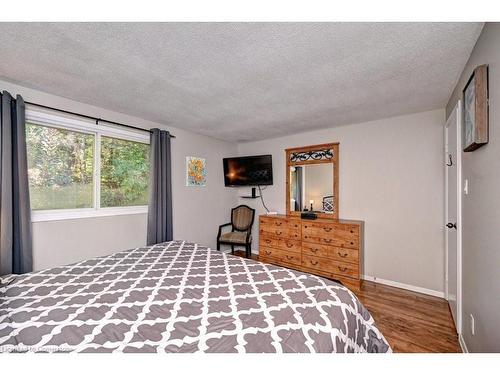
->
[463,65,489,152]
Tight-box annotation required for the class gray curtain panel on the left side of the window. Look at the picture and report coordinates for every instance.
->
[0,91,33,275]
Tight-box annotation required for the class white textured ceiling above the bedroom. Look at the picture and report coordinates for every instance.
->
[0,23,482,141]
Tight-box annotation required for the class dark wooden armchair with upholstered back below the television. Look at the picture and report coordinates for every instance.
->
[217,204,255,258]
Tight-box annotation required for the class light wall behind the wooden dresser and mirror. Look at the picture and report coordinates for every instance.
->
[238,110,445,292]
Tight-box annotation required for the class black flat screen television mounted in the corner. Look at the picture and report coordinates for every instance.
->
[224,155,273,186]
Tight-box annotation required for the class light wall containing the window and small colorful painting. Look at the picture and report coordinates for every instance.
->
[0,81,237,270]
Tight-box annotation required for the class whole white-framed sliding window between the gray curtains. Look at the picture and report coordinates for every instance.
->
[26,111,149,221]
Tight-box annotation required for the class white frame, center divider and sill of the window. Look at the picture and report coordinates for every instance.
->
[26,109,150,222]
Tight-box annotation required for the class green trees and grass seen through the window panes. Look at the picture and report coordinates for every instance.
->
[26,123,149,210]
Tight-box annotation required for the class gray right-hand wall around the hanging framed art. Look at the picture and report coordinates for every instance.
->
[446,23,500,352]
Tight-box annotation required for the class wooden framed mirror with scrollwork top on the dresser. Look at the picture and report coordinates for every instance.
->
[285,142,339,219]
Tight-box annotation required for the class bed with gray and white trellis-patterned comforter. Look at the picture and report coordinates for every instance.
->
[0,241,391,353]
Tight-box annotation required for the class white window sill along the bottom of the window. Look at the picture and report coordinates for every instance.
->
[31,206,148,223]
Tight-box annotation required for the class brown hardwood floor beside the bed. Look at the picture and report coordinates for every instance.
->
[235,251,461,353]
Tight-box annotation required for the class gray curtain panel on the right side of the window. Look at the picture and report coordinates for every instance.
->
[148,129,172,245]
